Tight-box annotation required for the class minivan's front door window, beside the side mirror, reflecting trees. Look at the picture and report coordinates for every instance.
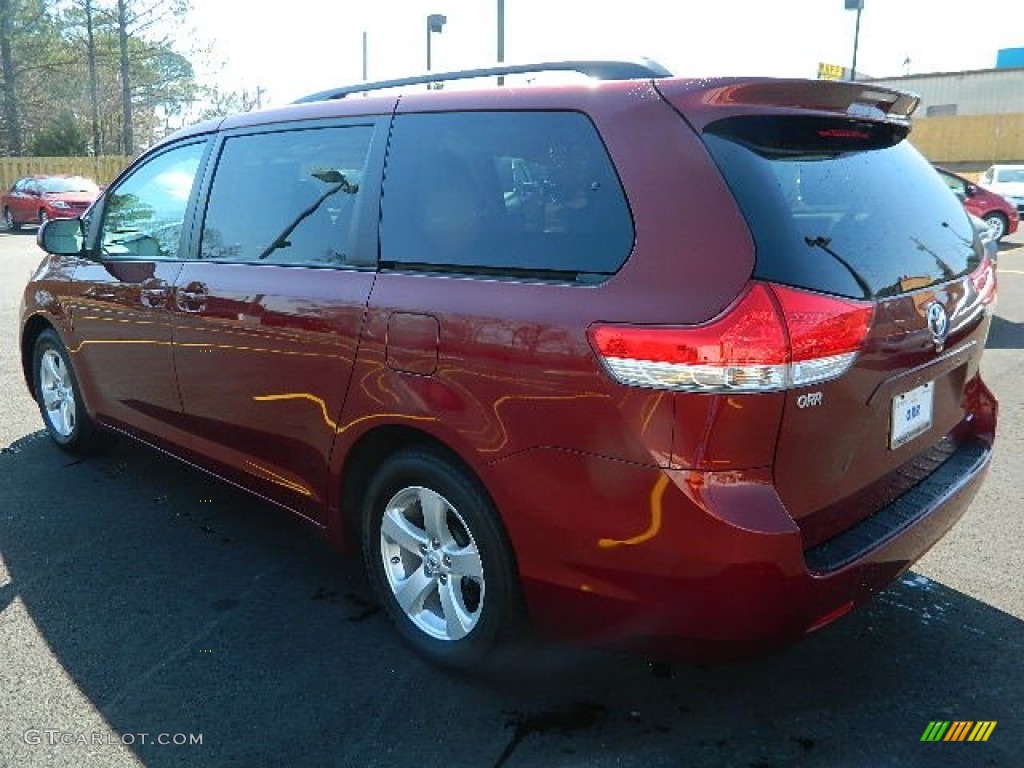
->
[99,142,206,259]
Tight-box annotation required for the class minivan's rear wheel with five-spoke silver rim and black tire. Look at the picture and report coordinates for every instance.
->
[362,450,521,669]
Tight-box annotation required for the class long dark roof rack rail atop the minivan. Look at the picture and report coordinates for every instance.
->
[294,58,672,104]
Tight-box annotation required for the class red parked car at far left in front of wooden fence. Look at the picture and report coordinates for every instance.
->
[0,175,99,230]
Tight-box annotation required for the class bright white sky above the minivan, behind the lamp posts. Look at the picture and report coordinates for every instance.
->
[189,0,1024,103]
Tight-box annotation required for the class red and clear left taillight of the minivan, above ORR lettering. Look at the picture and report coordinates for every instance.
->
[590,283,872,392]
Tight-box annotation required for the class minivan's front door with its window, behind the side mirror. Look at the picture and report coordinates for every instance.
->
[71,141,206,445]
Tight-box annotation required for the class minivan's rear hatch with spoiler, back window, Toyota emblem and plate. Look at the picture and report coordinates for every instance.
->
[658,81,994,561]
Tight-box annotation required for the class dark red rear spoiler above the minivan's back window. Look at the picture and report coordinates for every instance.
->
[653,78,921,130]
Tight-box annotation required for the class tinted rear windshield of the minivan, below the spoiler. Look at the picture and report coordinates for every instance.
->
[703,117,983,299]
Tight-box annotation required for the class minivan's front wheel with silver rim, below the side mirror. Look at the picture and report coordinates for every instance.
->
[32,329,109,454]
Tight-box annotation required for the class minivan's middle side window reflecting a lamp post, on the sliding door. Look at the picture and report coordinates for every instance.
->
[200,125,374,266]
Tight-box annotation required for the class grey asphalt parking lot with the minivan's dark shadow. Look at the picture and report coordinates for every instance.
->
[0,225,1024,768]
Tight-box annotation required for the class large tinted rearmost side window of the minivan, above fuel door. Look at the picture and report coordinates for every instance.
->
[381,112,634,280]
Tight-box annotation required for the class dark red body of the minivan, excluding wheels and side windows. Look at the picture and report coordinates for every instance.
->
[22,69,996,655]
